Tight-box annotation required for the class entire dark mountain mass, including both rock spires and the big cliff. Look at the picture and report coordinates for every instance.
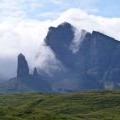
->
[0,22,120,92]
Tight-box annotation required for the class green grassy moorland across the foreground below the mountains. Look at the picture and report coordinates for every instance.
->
[0,91,120,120]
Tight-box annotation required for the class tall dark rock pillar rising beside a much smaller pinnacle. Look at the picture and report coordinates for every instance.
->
[17,54,29,77]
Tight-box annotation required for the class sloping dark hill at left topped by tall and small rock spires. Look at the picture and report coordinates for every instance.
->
[0,54,51,92]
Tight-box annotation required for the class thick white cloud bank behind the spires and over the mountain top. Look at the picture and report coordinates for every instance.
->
[0,9,120,80]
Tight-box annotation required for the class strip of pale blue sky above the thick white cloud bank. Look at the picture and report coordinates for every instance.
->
[0,0,120,20]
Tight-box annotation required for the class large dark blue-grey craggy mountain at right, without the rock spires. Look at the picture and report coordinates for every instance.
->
[45,23,120,90]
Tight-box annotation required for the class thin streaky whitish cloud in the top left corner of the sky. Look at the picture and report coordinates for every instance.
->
[0,0,44,19]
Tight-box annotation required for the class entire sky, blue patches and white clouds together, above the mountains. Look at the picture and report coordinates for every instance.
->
[0,0,120,78]
